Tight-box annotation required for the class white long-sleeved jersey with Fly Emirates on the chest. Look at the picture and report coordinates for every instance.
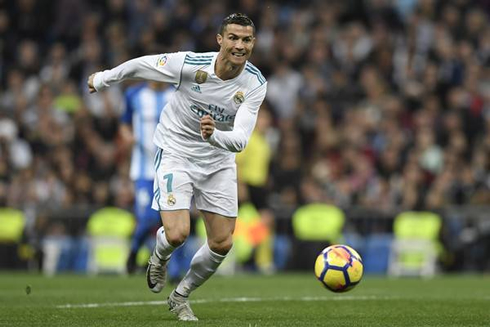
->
[94,52,267,169]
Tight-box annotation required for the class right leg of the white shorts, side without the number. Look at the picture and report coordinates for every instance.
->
[194,166,238,218]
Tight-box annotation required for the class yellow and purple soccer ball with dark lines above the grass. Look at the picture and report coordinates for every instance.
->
[315,245,363,292]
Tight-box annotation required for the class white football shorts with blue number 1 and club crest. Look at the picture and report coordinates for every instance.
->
[151,149,238,218]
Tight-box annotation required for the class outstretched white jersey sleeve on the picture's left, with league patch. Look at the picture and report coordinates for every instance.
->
[94,52,186,91]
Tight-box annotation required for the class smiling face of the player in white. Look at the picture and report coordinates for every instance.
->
[217,24,255,65]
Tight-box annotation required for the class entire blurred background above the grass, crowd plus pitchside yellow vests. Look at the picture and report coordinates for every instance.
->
[0,0,490,278]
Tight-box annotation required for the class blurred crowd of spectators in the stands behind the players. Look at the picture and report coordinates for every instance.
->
[0,0,490,228]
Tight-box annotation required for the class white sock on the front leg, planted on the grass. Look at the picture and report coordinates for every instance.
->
[176,242,226,296]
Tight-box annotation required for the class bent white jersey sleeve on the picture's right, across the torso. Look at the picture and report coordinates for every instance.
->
[206,83,267,152]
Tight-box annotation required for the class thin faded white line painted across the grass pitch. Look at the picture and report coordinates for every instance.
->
[56,295,397,309]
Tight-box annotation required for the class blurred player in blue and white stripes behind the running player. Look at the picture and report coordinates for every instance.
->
[119,82,175,274]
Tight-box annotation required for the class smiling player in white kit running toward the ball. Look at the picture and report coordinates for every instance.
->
[88,14,267,321]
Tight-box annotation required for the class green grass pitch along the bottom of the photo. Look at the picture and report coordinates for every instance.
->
[0,273,490,327]
